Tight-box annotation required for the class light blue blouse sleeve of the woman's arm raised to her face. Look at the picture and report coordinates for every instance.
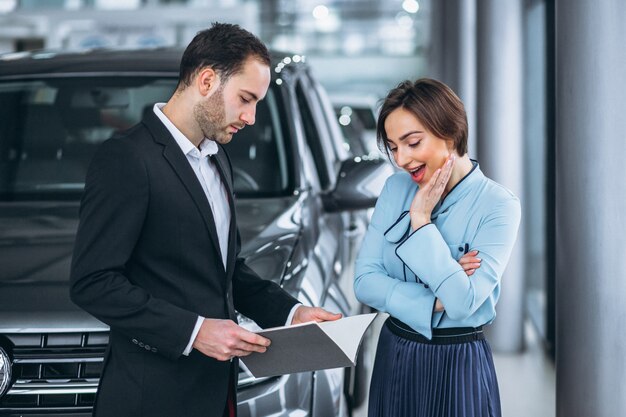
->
[396,197,521,320]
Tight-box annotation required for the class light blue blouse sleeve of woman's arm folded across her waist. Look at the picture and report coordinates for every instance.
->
[354,177,438,338]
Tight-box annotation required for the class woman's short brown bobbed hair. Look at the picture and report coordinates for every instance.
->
[376,78,467,156]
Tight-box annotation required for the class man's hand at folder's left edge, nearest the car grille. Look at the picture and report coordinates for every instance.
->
[193,319,270,361]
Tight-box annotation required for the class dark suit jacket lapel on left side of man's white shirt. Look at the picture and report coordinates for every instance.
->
[143,112,224,266]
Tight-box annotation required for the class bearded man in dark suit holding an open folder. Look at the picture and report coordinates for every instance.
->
[71,23,339,417]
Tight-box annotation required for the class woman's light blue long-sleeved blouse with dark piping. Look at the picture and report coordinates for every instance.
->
[354,162,521,339]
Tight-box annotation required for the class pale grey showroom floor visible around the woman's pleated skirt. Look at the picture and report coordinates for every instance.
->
[353,315,555,417]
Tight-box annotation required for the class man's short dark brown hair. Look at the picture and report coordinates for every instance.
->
[177,22,270,89]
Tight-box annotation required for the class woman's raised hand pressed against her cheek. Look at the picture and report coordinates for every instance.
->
[409,154,455,230]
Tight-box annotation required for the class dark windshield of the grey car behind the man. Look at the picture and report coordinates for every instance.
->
[0,76,290,201]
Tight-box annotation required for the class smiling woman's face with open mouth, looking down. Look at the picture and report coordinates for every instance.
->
[385,107,453,186]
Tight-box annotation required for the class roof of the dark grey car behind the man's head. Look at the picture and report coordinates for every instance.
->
[0,47,301,80]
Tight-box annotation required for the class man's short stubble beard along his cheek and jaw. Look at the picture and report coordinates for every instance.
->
[193,85,233,145]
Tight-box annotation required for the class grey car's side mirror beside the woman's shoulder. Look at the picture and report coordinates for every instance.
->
[323,156,393,212]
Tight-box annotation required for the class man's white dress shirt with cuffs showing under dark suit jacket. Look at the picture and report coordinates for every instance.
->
[153,103,301,356]
